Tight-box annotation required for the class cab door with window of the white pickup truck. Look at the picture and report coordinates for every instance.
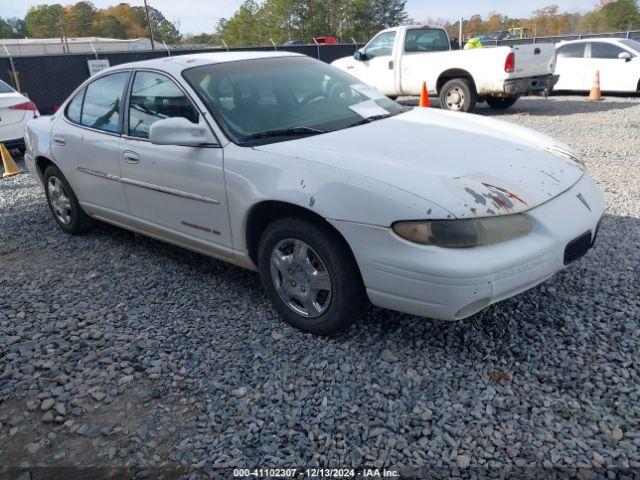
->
[356,30,397,95]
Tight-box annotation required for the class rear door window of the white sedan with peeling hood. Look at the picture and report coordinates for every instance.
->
[80,72,129,133]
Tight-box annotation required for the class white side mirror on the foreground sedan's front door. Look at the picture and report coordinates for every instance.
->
[149,117,218,147]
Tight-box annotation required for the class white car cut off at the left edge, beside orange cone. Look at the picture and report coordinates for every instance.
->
[0,80,39,150]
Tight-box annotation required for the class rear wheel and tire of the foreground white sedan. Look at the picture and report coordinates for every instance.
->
[43,165,94,235]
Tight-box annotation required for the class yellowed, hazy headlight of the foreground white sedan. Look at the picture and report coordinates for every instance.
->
[392,214,531,248]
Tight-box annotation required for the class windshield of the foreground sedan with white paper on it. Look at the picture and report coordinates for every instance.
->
[183,57,407,145]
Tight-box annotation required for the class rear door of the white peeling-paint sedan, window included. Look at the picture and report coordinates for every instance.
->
[51,71,130,214]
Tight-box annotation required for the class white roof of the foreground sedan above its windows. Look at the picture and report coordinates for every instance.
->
[101,51,305,74]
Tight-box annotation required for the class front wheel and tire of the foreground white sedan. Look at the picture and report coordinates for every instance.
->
[258,217,368,336]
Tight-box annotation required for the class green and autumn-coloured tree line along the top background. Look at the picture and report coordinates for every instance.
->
[0,0,640,46]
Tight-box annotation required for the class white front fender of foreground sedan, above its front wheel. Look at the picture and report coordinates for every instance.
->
[225,144,453,252]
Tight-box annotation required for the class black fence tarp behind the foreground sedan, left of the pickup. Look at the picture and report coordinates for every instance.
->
[0,44,357,114]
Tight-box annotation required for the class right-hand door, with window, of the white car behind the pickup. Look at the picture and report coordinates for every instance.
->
[588,42,638,92]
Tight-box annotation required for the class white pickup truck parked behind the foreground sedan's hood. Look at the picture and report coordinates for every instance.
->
[333,25,558,112]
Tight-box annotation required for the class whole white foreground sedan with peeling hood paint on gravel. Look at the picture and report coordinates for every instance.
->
[26,52,603,335]
